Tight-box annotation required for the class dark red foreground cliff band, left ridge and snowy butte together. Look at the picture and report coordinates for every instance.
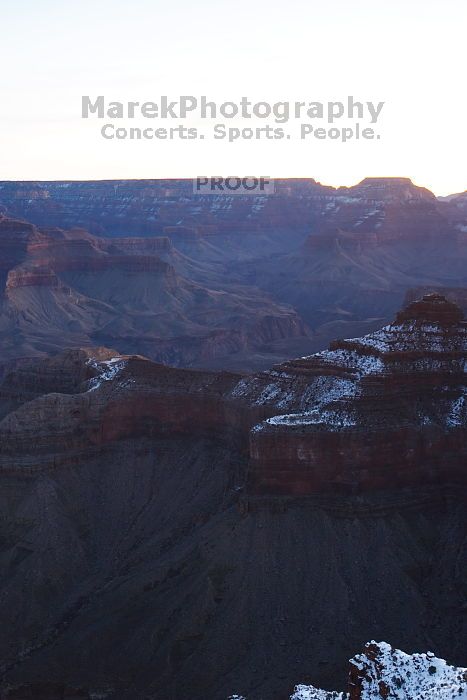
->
[0,294,467,495]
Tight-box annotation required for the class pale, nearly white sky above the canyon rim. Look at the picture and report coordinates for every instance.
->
[0,0,467,195]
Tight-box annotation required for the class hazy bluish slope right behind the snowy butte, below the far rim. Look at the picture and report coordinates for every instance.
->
[241,224,467,345]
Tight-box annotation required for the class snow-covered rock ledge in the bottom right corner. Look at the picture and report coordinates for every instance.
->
[229,641,467,700]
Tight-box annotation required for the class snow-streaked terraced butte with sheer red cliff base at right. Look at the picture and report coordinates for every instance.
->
[249,294,467,494]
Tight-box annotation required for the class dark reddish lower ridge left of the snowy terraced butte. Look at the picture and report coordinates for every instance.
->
[0,348,252,474]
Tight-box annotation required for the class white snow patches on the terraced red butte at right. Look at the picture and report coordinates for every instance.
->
[238,320,467,432]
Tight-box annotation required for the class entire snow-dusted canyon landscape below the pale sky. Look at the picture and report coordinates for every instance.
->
[0,178,467,700]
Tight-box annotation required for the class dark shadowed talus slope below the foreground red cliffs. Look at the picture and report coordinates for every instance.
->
[1,454,467,700]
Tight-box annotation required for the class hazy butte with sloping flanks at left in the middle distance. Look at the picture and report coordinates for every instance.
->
[0,218,310,366]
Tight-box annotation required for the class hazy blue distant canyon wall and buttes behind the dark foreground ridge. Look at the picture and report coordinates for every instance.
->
[0,178,467,371]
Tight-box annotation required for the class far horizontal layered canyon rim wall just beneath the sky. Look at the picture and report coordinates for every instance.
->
[0,178,456,238]
